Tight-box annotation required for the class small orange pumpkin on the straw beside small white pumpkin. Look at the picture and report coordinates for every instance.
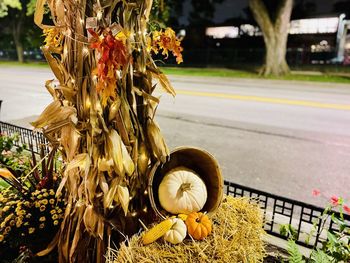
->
[185,212,212,240]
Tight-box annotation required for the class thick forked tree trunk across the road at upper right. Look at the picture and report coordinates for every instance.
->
[249,0,293,76]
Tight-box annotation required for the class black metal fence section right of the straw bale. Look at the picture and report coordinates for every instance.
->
[225,181,350,250]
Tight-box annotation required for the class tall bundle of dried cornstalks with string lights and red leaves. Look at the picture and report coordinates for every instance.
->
[33,0,180,262]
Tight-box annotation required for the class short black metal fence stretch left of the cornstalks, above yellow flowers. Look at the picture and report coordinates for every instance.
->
[0,121,48,154]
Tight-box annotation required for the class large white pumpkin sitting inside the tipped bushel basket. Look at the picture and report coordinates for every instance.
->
[158,167,208,214]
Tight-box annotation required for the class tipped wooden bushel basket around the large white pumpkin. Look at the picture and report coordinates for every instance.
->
[148,146,224,219]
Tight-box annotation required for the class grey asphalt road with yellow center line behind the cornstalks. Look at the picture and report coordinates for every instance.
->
[0,67,350,209]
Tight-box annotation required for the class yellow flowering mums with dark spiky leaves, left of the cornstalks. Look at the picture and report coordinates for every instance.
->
[0,147,65,259]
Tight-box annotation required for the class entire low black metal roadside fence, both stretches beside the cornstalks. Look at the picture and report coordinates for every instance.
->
[0,122,350,250]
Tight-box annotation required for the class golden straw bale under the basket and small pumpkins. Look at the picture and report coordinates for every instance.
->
[107,196,265,263]
